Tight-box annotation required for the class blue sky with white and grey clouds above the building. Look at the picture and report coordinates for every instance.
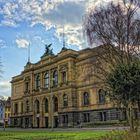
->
[0,0,112,97]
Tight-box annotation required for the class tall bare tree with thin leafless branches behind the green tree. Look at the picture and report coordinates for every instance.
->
[84,0,140,131]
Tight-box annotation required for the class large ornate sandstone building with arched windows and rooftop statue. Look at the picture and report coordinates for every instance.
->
[11,47,123,127]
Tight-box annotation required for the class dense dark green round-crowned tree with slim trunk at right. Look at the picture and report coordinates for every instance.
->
[106,60,140,131]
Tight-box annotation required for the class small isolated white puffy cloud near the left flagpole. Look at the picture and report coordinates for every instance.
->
[16,38,30,48]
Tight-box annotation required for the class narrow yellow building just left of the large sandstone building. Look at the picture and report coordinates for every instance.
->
[4,97,11,125]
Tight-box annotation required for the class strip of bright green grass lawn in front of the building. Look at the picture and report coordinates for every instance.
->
[0,131,113,140]
